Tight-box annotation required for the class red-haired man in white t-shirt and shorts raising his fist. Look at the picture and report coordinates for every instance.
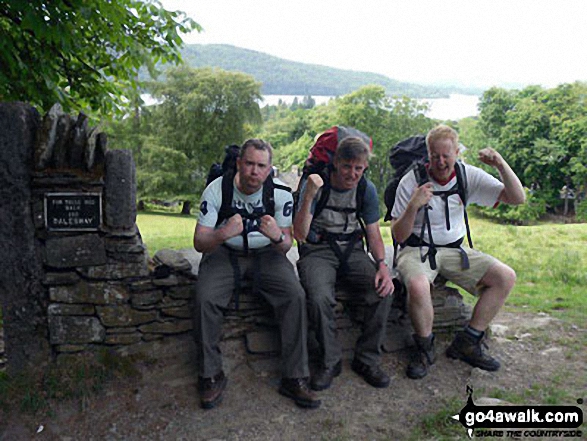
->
[391,125,526,379]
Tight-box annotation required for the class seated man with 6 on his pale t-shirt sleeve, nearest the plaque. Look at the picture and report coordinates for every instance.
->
[194,139,320,409]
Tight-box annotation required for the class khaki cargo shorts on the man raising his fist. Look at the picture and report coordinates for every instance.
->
[397,247,500,295]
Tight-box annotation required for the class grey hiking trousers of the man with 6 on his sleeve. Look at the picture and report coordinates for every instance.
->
[194,246,309,378]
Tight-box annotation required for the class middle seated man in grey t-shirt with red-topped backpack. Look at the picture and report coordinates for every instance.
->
[294,137,393,390]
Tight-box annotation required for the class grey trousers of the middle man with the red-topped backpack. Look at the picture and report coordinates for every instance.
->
[297,241,392,368]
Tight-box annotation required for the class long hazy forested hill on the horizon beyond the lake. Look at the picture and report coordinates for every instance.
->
[181,44,480,98]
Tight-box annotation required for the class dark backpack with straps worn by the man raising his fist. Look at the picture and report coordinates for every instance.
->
[384,135,473,270]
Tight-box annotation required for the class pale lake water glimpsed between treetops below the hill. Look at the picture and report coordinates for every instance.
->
[261,93,479,120]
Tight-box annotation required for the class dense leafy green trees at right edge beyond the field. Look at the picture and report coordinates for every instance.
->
[479,82,587,210]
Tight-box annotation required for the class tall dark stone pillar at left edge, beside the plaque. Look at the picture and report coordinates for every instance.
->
[0,103,50,372]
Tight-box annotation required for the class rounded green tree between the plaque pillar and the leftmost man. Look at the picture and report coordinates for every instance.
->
[109,67,261,202]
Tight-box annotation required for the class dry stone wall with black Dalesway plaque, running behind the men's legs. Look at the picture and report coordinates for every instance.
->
[0,103,470,371]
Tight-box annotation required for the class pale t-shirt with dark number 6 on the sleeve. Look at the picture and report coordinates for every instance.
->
[198,177,293,250]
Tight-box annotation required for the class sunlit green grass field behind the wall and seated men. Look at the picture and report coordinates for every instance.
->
[137,211,587,323]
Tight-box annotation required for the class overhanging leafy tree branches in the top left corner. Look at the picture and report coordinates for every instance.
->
[0,0,200,114]
